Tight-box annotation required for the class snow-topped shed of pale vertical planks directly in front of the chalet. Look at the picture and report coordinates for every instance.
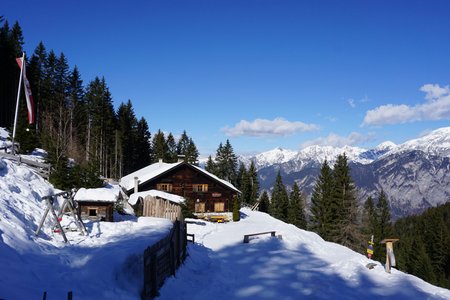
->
[128,190,186,221]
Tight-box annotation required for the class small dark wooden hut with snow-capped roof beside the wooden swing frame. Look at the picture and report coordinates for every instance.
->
[74,186,120,222]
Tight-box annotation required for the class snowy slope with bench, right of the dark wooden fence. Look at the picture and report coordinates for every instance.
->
[159,209,450,300]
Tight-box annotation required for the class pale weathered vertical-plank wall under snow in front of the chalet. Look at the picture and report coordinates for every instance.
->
[142,196,183,221]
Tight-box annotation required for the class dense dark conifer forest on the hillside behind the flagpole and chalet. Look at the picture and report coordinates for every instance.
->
[0,18,199,189]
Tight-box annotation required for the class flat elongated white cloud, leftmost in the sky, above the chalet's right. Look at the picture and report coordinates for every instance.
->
[222,118,319,137]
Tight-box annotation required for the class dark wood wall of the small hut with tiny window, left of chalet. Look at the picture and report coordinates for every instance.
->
[77,201,114,222]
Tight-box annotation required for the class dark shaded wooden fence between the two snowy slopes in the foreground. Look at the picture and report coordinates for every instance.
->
[141,221,187,300]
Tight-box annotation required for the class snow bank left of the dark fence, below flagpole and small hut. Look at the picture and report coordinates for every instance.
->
[0,159,172,299]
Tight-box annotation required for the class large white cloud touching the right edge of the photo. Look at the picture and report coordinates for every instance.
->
[362,84,450,126]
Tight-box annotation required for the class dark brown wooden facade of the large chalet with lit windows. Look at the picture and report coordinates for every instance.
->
[129,163,238,213]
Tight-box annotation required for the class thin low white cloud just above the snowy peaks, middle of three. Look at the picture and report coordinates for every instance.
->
[301,132,373,148]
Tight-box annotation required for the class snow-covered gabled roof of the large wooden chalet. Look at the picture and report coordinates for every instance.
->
[119,162,240,193]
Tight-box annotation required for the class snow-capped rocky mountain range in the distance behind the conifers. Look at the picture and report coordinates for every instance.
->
[241,127,450,219]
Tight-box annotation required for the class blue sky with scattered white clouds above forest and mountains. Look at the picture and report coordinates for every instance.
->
[0,0,450,156]
